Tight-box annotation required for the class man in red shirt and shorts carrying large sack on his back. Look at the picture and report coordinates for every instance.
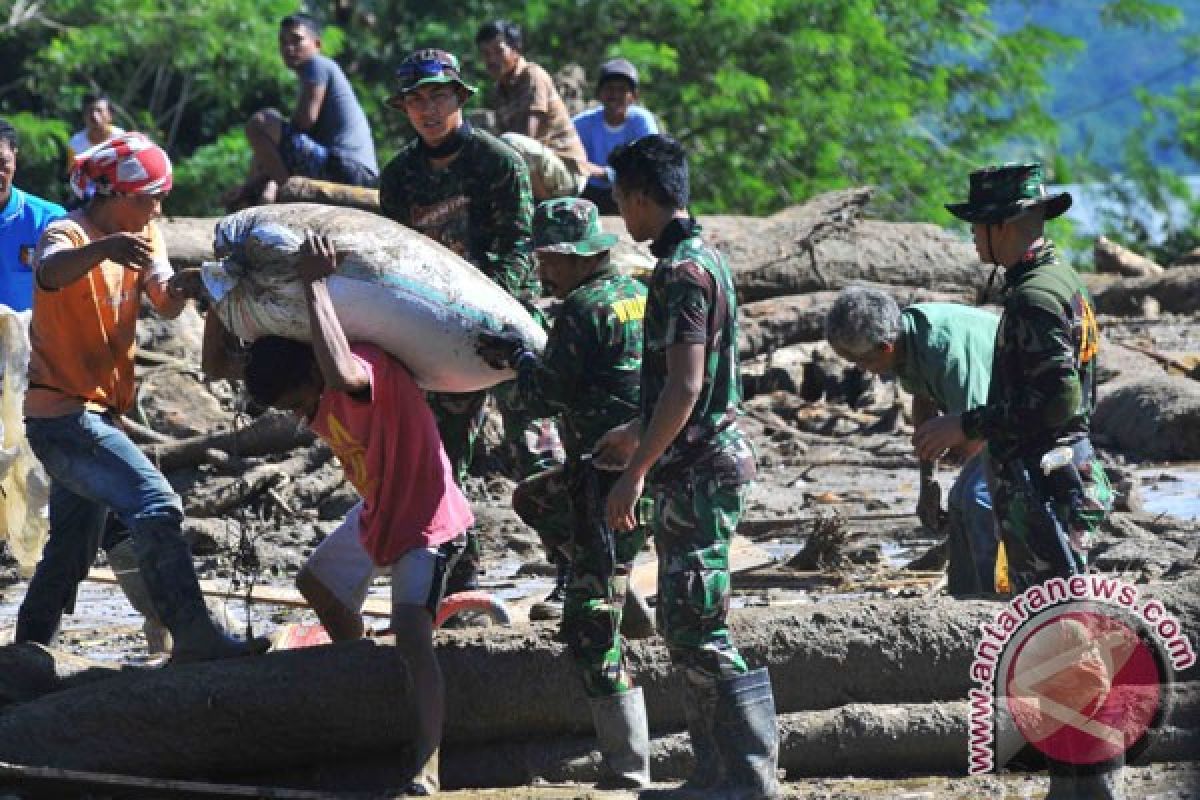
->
[223,234,474,795]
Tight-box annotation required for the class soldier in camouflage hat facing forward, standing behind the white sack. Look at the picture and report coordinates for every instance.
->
[379,49,556,591]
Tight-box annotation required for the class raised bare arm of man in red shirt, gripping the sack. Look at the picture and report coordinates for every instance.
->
[296,233,371,395]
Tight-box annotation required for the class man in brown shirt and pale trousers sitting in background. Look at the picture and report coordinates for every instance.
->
[475,19,588,200]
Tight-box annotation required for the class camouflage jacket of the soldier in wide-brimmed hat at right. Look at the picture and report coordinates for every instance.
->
[962,239,1099,462]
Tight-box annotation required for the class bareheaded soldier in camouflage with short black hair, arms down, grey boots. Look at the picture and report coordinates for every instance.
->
[598,134,779,798]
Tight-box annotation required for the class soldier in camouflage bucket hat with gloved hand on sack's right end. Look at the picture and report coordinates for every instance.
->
[479,198,650,789]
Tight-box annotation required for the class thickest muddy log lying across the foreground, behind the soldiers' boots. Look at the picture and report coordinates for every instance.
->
[0,579,1200,776]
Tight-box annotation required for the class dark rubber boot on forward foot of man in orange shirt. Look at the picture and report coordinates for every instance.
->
[132,521,270,663]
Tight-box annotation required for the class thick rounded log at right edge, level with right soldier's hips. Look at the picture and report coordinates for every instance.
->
[1092,375,1200,461]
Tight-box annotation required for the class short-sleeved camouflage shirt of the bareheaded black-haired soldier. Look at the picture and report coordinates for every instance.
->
[642,218,755,485]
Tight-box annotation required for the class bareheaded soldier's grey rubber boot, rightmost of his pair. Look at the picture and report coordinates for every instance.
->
[713,667,780,800]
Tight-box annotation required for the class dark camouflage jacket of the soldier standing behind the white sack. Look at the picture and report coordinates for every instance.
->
[379,128,540,301]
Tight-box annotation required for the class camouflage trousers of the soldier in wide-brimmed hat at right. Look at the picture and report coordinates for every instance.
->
[988,440,1112,593]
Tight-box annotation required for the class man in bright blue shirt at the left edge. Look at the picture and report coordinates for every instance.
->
[0,119,66,311]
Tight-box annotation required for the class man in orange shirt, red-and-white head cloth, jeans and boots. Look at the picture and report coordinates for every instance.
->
[16,133,265,661]
